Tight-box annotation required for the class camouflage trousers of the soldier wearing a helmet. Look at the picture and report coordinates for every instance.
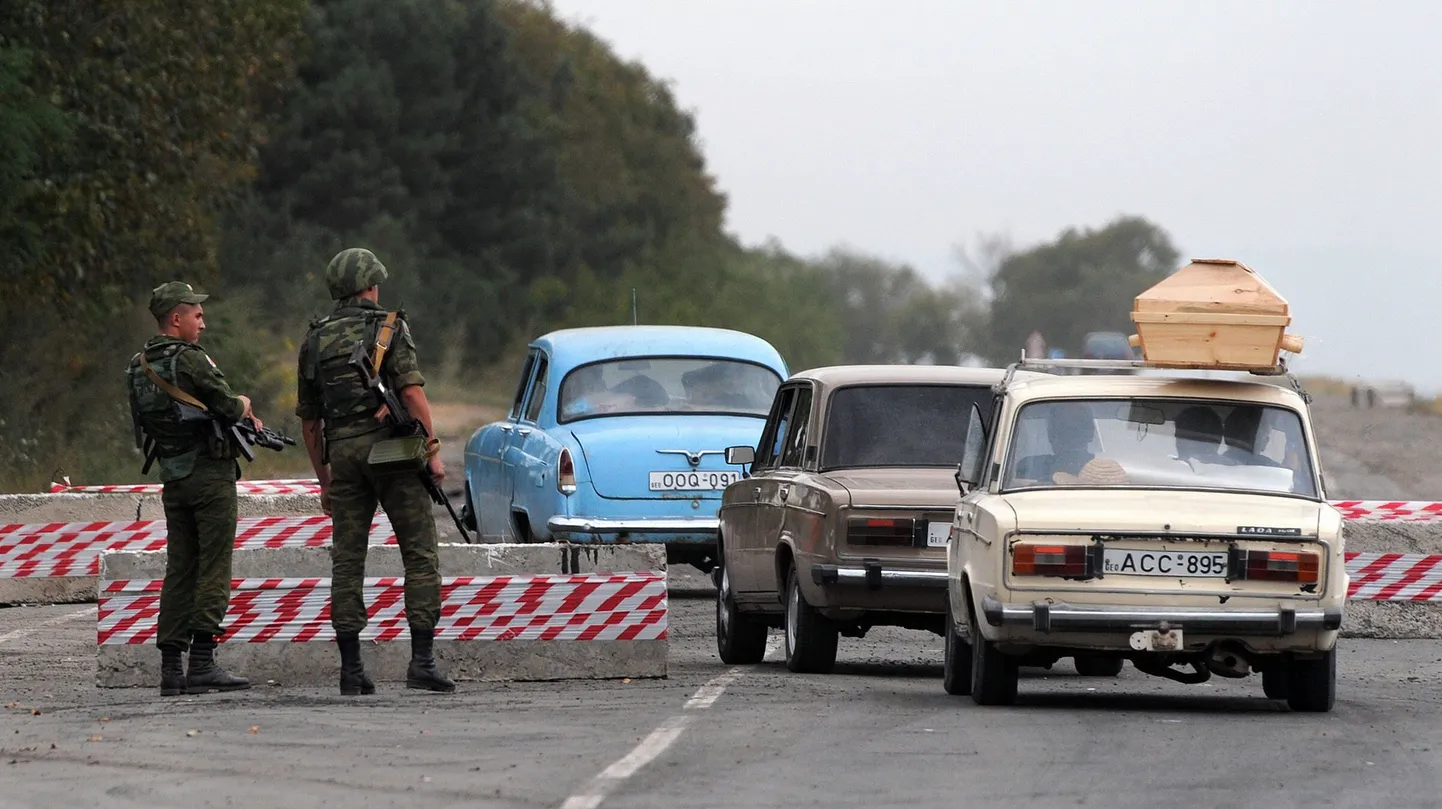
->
[330,430,441,633]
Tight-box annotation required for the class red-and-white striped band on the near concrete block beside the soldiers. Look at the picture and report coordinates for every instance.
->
[97,571,666,646]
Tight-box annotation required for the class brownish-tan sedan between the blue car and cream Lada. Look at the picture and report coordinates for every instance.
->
[712,365,1026,672]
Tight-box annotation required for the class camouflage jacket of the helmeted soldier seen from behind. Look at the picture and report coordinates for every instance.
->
[296,297,425,441]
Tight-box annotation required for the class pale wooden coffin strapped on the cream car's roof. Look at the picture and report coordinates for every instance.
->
[1131,258,1302,371]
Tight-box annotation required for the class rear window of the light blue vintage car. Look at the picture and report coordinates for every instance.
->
[559,356,782,421]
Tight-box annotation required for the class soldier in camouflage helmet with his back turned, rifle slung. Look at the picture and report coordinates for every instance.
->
[296,248,456,695]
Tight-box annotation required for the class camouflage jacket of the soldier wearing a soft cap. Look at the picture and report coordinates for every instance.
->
[125,335,245,483]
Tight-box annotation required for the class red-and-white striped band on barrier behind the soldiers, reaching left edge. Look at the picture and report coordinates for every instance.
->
[0,512,395,578]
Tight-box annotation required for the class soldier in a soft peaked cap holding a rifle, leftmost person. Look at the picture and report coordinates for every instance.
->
[125,281,261,697]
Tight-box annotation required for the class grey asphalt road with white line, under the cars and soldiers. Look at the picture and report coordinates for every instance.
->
[0,590,1442,809]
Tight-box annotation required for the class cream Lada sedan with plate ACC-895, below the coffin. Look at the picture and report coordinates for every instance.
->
[945,361,1348,711]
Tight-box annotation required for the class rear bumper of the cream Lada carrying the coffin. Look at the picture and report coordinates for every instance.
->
[982,596,1343,636]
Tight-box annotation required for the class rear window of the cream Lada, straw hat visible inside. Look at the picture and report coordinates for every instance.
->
[1002,399,1317,498]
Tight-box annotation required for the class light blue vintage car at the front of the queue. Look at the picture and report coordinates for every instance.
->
[461,326,789,571]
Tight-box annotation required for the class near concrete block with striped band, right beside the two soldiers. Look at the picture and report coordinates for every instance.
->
[97,544,668,688]
